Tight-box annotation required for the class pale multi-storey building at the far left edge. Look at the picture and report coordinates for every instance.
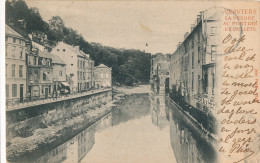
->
[5,25,27,102]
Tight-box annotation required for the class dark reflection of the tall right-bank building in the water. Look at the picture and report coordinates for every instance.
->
[167,97,216,163]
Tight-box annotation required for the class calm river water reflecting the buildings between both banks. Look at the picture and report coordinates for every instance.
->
[32,94,216,163]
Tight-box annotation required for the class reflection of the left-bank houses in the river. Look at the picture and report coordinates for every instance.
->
[34,113,112,163]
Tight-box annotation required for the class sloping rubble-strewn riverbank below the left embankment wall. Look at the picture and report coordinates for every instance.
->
[6,101,113,162]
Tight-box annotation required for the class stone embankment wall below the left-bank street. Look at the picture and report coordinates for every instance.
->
[6,90,112,139]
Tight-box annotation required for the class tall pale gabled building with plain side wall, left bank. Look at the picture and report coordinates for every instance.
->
[51,42,94,92]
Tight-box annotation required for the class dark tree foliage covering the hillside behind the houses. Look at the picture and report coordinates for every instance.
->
[6,0,151,85]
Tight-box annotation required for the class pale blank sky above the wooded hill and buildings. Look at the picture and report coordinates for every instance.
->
[26,1,217,54]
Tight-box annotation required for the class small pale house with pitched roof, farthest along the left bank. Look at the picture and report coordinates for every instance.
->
[94,64,112,88]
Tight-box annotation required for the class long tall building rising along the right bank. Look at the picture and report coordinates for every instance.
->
[169,10,220,113]
